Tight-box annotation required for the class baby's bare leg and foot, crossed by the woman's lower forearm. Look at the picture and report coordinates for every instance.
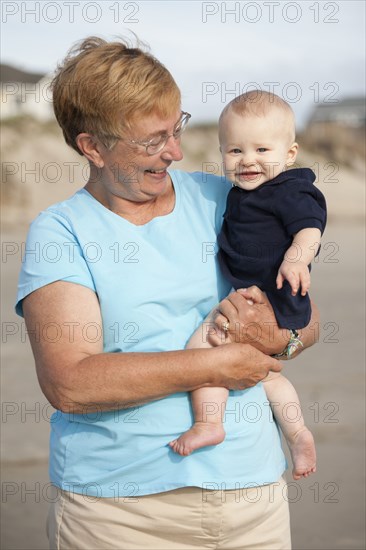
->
[169,323,229,456]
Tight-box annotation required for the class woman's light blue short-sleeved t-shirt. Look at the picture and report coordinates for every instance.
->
[16,171,286,497]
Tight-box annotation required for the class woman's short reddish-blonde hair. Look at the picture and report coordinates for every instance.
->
[52,36,181,154]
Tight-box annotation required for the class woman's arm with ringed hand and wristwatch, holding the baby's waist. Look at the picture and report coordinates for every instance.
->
[214,286,319,357]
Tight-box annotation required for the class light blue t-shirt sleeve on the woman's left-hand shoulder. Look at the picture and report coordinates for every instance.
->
[15,210,95,316]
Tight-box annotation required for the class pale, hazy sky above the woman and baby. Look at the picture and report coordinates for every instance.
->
[1,0,366,128]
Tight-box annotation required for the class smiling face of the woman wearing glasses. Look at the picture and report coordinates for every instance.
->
[101,111,183,202]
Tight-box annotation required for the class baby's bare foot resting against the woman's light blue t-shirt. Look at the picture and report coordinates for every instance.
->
[169,422,225,456]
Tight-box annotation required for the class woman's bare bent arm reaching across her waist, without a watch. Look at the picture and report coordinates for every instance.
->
[23,281,281,414]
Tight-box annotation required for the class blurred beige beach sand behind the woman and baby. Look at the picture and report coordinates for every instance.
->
[1,123,365,550]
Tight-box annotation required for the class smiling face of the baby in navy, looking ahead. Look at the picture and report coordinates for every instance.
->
[219,109,297,191]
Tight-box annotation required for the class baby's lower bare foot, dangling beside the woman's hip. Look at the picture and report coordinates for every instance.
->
[288,427,316,479]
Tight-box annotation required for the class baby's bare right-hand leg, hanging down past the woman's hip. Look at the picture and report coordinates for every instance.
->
[263,373,316,479]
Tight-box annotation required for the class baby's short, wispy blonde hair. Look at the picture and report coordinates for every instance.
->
[219,90,296,142]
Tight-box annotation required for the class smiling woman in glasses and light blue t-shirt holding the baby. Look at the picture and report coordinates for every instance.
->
[17,37,314,550]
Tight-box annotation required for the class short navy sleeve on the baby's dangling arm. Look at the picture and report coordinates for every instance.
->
[272,182,327,235]
